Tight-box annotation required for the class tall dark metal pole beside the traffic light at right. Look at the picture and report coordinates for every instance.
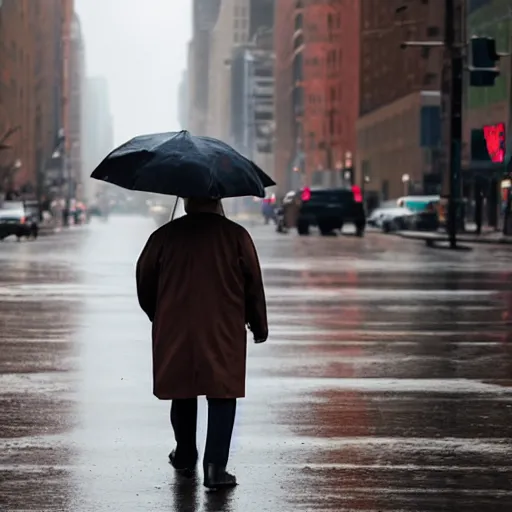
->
[445,0,464,249]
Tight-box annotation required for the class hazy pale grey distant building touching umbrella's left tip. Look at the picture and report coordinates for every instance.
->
[82,76,114,202]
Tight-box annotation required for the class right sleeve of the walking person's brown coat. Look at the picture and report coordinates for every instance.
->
[241,231,268,342]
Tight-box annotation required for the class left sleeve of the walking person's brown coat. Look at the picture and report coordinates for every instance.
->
[136,235,160,322]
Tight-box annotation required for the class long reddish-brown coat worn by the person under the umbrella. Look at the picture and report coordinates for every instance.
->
[137,213,268,400]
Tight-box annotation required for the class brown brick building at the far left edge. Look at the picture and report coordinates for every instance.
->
[0,0,73,196]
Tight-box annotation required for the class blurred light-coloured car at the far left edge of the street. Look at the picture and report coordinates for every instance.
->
[0,201,41,241]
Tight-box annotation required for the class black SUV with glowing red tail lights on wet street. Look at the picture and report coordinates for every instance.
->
[277,187,366,236]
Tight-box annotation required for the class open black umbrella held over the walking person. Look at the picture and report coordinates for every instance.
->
[91,130,275,198]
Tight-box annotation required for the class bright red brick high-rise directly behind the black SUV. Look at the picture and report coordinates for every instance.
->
[275,0,359,193]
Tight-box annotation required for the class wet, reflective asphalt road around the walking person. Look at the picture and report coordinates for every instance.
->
[0,218,512,512]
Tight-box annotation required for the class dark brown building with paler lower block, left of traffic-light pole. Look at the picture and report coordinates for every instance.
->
[356,0,444,201]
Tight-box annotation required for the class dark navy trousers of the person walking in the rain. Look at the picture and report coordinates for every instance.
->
[171,398,236,468]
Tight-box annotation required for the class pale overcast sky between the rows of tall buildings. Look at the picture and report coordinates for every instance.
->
[75,0,192,144]
